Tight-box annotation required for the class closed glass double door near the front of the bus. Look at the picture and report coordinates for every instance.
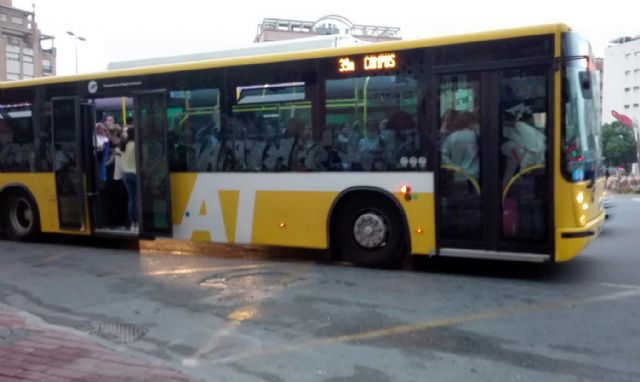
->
[435,67,551,258]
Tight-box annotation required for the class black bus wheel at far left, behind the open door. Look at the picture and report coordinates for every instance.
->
[2,191,40,240]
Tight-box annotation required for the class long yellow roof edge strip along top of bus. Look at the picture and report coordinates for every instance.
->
[0,23,570,89]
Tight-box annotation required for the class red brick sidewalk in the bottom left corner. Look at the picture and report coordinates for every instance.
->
[0,304,199,382]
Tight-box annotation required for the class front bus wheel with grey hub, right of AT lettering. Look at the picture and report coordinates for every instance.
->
[332,195,407,268]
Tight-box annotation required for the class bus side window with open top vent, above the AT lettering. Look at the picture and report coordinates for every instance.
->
[226,74,317,171]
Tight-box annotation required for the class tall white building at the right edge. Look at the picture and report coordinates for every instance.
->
[602,35,640,123]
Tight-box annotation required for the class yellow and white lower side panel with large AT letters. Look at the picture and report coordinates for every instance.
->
[171,172,435,254]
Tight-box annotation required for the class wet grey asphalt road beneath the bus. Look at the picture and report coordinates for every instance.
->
[0,197,640,381]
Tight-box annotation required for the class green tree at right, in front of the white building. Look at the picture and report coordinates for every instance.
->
[602,121,637,170]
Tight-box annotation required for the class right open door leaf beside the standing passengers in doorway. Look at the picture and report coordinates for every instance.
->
[133,90,173,236]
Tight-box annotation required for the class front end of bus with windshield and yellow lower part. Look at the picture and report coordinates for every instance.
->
[554,32,605,262]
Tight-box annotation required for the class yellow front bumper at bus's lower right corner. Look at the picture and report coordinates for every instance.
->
[555,211,606,262]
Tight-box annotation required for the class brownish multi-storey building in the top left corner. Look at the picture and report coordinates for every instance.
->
[0,0,56,81]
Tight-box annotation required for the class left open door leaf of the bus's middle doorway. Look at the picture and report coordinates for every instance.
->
[51,97,87,232]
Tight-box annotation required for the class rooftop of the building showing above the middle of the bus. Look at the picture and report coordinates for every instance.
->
[254,15,401,42]
